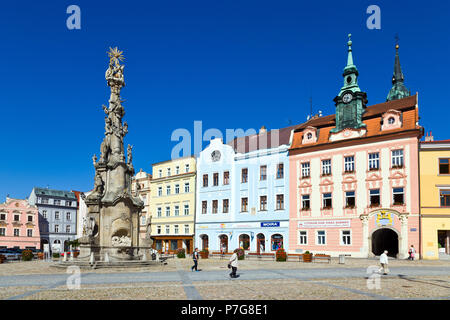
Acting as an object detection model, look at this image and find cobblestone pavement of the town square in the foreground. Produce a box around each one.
[0,259,450,300]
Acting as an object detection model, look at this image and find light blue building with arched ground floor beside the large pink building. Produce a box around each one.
[195,126,296,253]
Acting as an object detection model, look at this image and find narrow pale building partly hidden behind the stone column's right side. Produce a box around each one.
[131,169,152,239]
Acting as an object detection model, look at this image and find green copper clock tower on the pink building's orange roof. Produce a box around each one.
[331,34,367,133]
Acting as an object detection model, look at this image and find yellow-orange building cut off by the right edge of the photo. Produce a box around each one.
[420,136,450,259]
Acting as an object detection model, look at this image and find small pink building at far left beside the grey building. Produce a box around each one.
[0,198,41,249]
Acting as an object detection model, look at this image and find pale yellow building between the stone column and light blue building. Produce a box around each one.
[150,156,196,254]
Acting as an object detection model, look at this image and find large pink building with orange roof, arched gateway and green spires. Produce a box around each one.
[289,41,423,259]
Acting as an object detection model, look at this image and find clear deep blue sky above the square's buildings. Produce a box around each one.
[0,0,450,201]
